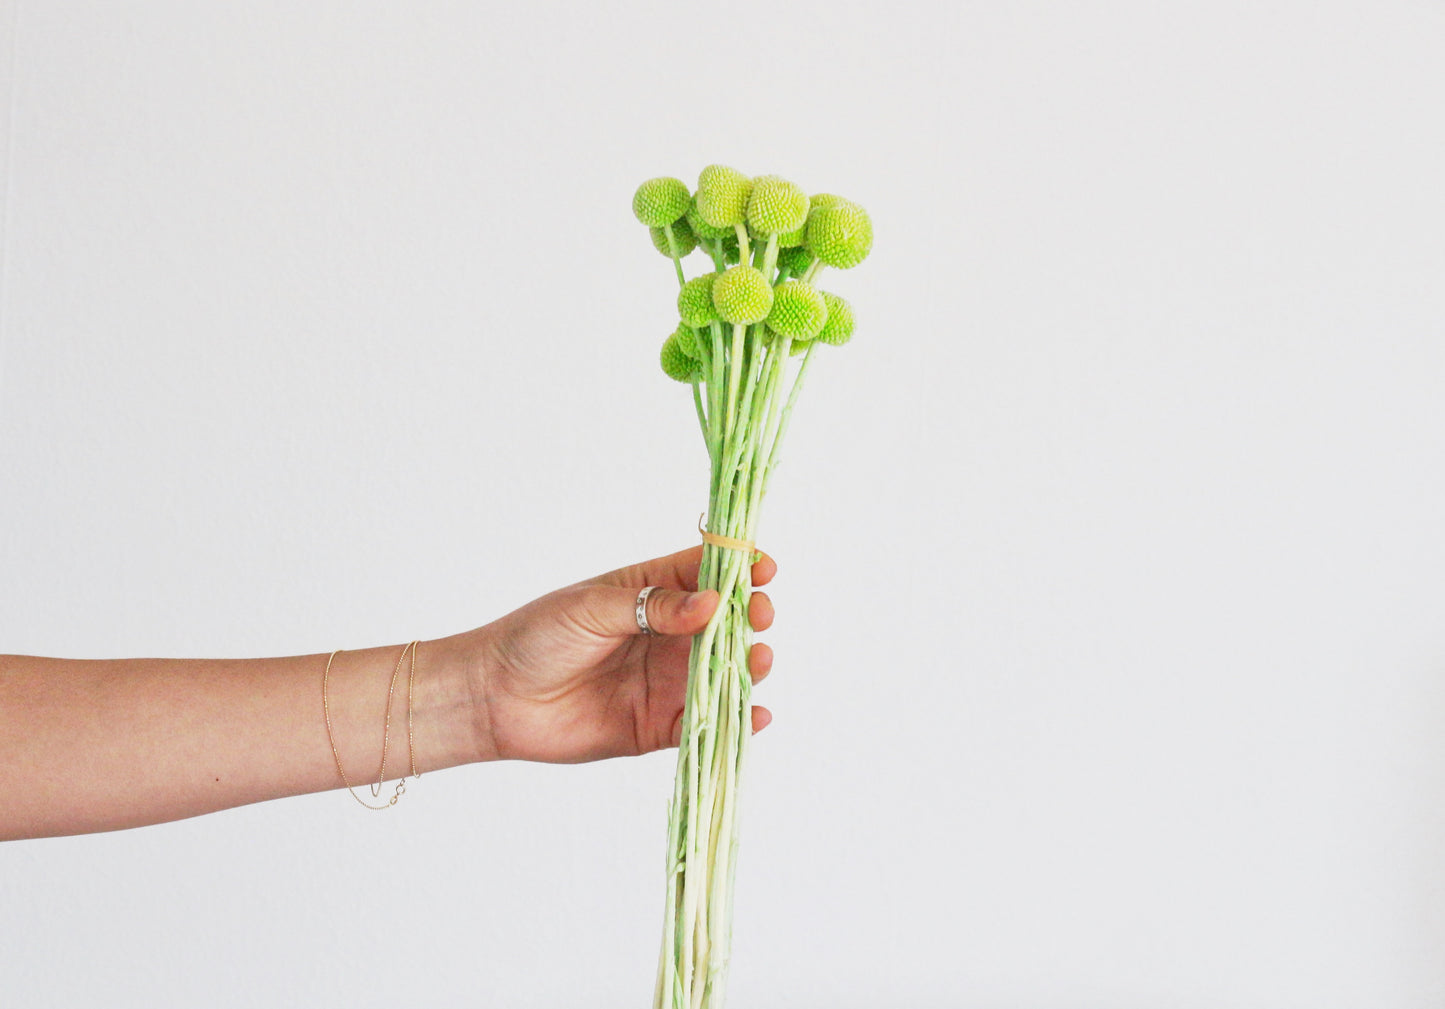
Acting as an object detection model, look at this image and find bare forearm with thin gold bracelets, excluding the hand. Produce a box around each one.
[0,636,486,840]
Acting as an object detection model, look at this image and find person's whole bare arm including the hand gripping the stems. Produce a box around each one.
[0,548,776,840]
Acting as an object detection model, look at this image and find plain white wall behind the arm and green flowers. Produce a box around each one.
[0,0,1445,1009]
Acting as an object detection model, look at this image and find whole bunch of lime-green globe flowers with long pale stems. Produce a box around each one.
[633,165,873,1009]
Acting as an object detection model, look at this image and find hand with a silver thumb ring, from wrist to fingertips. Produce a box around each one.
[468,546,777,763]
